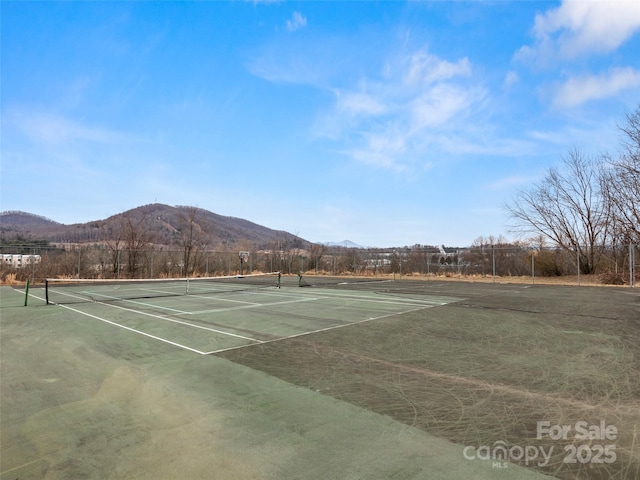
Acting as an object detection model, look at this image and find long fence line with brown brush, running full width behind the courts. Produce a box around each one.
[0,245,640,286]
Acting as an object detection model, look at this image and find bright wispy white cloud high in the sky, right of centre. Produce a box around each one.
[320,49,486,171]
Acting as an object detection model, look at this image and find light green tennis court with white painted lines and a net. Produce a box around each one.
[41,275,459,354]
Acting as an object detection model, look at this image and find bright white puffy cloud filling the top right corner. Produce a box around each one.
[516,0,640,63]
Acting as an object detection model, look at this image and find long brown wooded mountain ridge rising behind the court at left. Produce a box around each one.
[0,203,309,249]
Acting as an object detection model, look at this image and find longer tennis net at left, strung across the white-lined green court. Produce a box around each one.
[45,272,280,304]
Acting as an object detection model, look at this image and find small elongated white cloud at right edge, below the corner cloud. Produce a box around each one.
[553,68,640,107]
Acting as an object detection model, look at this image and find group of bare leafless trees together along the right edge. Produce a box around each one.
[507,105,640,274]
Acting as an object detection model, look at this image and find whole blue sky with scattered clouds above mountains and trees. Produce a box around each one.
[0,1,640,247]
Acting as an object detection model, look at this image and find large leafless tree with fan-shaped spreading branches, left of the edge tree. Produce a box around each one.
[507,150,610,274]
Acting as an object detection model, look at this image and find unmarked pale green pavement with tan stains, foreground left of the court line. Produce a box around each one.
[0,287,552,480]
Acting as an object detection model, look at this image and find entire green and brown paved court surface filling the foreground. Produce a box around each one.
[0,278,640,479]
